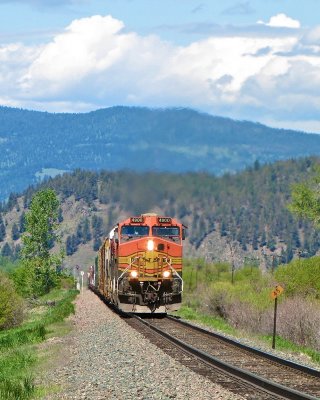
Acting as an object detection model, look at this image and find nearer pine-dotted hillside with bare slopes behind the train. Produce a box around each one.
[0,158,320,267]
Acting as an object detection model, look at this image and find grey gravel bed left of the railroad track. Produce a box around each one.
[42,290,243,400]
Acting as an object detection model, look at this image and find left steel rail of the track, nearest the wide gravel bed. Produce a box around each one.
[133,315,319,400]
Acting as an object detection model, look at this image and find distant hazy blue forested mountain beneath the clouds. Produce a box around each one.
[0,107,320,199]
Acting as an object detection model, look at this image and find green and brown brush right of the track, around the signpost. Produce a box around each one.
[178,257,320,363]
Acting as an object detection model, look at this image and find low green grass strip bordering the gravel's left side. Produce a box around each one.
[0,289,78,400]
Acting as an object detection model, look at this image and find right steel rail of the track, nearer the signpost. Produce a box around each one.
[166,315,320,379]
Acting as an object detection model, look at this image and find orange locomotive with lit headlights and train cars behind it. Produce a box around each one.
[89,214,186,313]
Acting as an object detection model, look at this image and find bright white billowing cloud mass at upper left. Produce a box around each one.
[22,15,123,90]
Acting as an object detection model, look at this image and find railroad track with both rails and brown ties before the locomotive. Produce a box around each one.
[126,316,320,400]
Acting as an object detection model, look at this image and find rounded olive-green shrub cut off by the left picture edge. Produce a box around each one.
[0,273,24,330]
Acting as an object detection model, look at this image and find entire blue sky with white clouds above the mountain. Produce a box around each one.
[0,0,320,133]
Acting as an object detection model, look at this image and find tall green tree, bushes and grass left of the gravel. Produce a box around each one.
[0,189,78,400]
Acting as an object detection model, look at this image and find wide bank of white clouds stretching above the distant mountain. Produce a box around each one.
[0,16,320,133]
